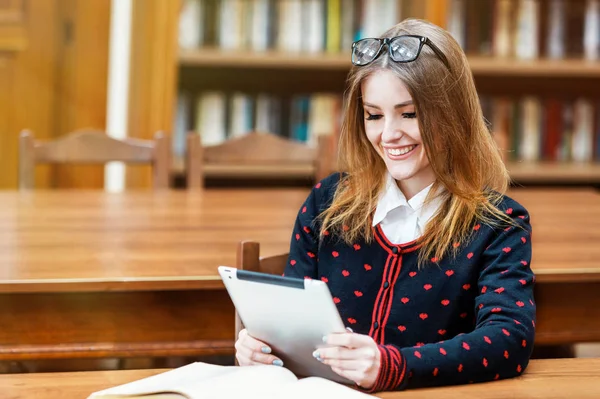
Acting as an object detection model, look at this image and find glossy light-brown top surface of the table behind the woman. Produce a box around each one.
[0,189,600,292]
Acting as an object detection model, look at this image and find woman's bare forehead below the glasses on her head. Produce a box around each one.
[361,69,411,106]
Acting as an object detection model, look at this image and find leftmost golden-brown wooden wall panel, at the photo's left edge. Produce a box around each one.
[0,0,58,188]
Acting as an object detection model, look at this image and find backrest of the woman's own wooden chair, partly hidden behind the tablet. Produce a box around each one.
[234,241,288,346]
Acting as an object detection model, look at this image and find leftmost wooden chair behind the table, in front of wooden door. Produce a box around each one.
[19,130,171,189]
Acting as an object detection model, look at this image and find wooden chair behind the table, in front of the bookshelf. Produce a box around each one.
[186,132,334,188]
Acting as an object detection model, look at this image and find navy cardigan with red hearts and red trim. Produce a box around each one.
[284,174,535,391]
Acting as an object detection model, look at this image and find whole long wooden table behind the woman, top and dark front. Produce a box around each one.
[0,189,600,360]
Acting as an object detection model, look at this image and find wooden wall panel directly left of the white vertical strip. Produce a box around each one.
[55,0,110,188]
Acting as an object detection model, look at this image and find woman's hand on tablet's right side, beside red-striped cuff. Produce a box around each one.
[313,332,381,389]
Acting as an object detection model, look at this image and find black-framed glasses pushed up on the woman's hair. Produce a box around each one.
[352,35,450,69]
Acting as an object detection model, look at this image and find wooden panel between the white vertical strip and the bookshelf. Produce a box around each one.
[126,0,181,188]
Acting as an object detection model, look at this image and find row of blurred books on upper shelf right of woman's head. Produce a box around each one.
[447,0,600,60]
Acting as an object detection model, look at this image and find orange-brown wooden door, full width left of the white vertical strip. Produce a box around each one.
[0,0,110,189]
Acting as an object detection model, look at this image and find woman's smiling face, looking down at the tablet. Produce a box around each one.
[361,69,435,199]
